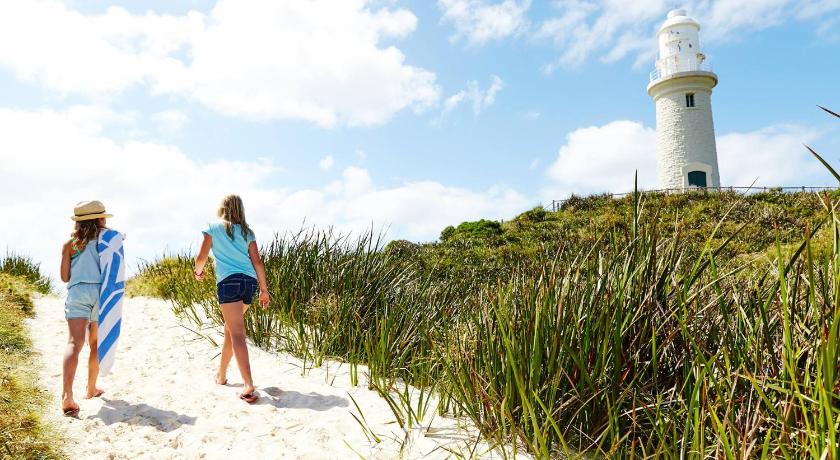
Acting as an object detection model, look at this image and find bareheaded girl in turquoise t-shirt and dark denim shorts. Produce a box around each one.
[195,195,269,404]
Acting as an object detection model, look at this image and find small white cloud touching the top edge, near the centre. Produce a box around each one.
[438,0,531,45]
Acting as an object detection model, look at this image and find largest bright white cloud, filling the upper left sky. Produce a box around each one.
[0,0,439,126]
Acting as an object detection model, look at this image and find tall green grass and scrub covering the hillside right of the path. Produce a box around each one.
[134,108,840,460]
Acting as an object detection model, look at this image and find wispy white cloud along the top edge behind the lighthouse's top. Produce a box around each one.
[534,0,840,71]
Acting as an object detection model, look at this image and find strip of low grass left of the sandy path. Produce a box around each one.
[0,255,62,459]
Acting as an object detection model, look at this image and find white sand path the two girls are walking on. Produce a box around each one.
[28,297,520,460]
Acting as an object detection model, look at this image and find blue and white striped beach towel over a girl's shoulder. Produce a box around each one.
[97,228,125,375]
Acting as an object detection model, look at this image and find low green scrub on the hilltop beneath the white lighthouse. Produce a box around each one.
[386,191,840,286]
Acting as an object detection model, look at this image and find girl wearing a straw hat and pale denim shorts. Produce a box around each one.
[61,201,112,417]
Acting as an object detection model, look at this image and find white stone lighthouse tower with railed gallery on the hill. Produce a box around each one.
[647,10,720,189]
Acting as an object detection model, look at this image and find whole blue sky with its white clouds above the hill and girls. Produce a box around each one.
[0,0,840,274]
